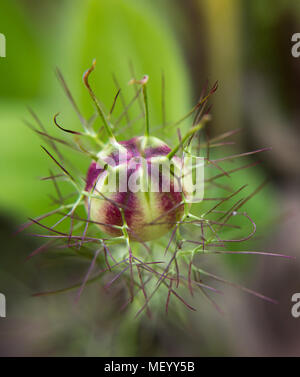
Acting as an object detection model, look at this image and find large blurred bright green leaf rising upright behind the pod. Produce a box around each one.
[60,0,190,139]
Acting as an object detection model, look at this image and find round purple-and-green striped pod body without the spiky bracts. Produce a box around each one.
[86,136,184,242]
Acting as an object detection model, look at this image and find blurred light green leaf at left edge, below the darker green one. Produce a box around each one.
[0,102,58,217]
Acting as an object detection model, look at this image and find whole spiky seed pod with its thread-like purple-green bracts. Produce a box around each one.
[22,62,292,315]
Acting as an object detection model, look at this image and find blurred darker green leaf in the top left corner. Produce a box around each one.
[0,0,45,99]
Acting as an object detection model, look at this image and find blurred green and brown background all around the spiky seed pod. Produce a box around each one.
[0,0,300,356]
